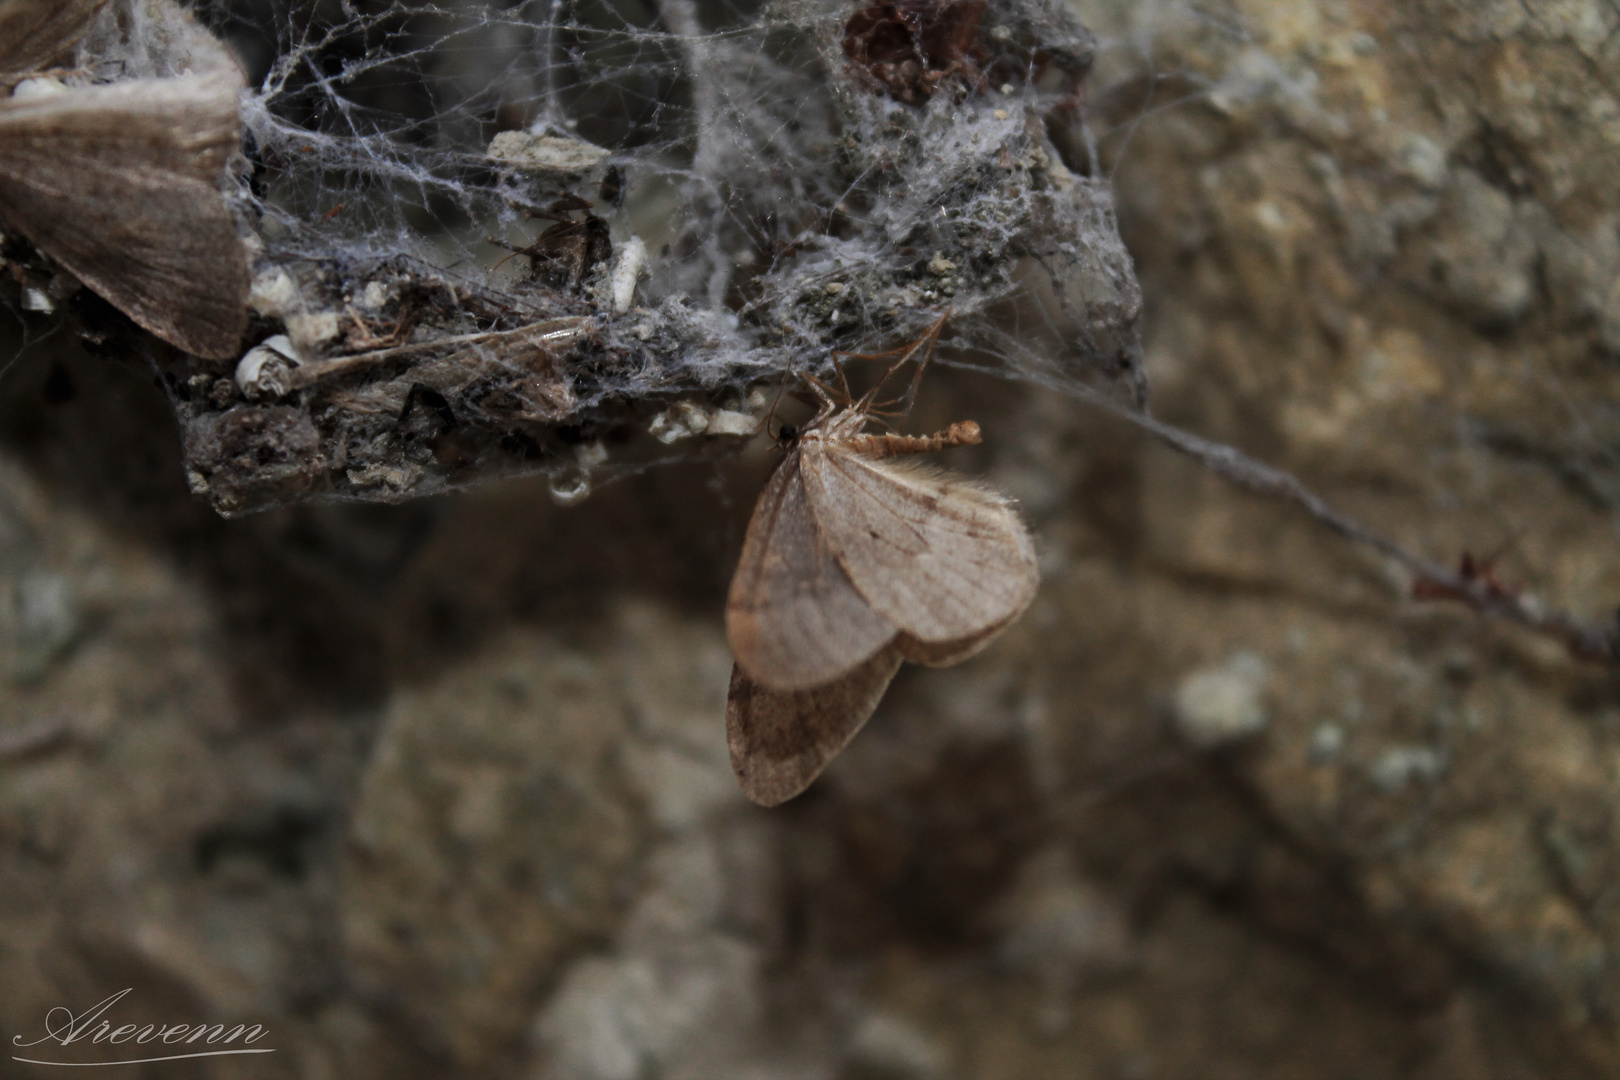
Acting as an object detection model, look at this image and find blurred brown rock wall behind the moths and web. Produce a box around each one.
[0,0,1620,1080]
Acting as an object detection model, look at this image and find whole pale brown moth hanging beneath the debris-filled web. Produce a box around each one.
[726,319,1040,806]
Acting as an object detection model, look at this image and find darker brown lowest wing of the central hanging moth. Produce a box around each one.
[726,646,901,806]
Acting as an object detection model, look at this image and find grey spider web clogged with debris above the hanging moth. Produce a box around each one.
[136,0,1145,513]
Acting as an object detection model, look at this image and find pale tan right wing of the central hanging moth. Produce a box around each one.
[804,444,1040,647]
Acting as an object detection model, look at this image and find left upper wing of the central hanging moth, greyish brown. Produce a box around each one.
[726,453,894,691]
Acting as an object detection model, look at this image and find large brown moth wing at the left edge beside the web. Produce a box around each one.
[0,71,248,358]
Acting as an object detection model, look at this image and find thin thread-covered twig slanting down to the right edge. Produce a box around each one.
[1066,387,1620,665]
